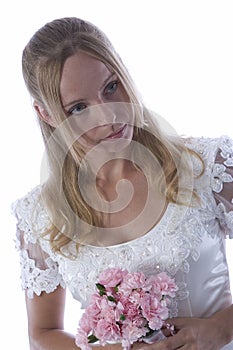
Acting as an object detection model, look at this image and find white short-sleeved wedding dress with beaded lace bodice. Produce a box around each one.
[12,136,233,350]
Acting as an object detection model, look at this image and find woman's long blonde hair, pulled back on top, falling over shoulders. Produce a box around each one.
[22,17,204,252]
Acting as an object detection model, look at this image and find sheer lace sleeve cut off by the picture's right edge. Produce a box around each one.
[211,137,233,238]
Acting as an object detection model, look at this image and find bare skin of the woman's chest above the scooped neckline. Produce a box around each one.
[90,174,166,246]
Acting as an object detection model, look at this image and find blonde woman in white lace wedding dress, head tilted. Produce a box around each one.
[13,18,233,350]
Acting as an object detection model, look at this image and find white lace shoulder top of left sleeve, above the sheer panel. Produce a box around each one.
[11,185,50,240]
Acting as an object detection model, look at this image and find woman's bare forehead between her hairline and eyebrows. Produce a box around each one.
[60,52,111,104]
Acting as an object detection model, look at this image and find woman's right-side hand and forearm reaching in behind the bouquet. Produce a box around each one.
[132,305,233,350]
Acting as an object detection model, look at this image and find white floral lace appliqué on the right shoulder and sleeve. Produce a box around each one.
[189,136,233,238]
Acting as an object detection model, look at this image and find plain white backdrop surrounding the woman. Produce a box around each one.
[0,0,233,350]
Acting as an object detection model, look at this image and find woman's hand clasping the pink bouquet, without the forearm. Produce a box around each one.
[133,317,225,350]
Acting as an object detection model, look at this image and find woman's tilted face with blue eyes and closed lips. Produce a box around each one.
[60,53,133,152]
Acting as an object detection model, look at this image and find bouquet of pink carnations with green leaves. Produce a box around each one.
[75,268,178,350]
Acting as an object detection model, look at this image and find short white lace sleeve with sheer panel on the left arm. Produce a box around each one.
[12,187,65,298]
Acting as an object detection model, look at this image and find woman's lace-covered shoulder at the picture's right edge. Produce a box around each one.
[187,135,233,238]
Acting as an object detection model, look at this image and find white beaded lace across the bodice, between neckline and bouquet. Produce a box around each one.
[60,205,203,308]
